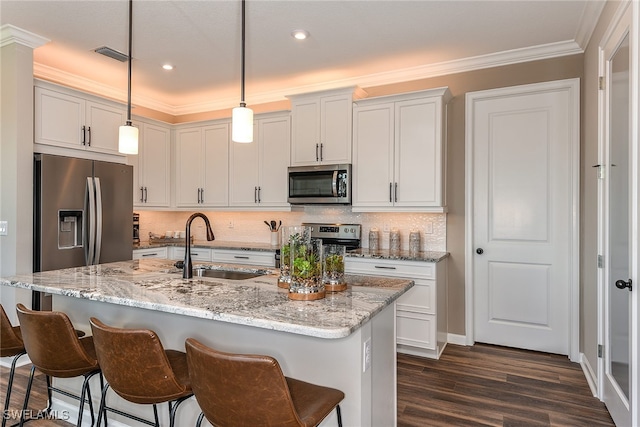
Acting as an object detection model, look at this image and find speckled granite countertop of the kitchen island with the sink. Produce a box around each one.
[0,259,413,339]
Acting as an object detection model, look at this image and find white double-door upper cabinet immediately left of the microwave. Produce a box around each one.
[229,112,291,210]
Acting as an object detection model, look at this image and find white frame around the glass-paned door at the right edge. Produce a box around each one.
[597,1,640,425]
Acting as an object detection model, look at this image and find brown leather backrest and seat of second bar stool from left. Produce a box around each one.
[16,304,100,378]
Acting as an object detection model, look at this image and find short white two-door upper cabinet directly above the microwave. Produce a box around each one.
[288,87,364,166]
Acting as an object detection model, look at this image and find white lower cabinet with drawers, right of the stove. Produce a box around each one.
[345,257,447,359]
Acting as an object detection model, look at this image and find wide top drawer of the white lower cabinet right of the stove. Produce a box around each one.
[345,257,436,279]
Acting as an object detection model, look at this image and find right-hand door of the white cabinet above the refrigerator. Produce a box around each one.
[85,101,126,154]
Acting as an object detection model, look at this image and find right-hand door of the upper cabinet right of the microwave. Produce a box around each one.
[394,98,442,207]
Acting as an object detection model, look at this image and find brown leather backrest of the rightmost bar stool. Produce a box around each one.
[185,338,305,427]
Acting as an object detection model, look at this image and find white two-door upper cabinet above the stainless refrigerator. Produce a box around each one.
[34,81,126,155]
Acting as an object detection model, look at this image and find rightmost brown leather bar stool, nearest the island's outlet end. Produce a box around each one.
[185,338,344,427]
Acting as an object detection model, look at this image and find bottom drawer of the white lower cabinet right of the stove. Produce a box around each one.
[396,310,437,350]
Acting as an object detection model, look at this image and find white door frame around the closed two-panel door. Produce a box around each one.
[464,78,580,362]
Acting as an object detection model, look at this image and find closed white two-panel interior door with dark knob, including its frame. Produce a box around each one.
[467,79,579,359]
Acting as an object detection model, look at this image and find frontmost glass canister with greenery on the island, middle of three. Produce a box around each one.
[289,239,326,301]
